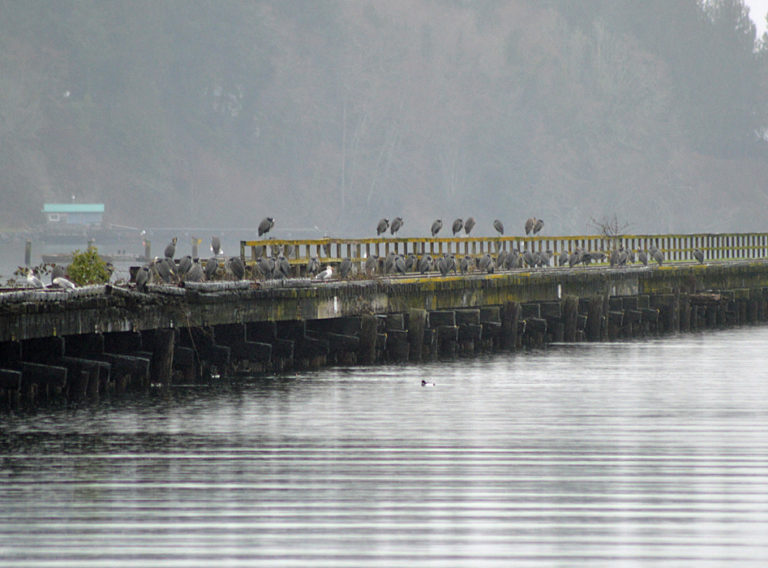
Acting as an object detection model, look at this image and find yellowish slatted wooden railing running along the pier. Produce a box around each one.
[240,233,768,264]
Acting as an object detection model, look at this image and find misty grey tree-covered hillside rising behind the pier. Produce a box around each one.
[0,0,768,238]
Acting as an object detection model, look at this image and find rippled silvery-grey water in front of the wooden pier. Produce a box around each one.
[0,328,768,567]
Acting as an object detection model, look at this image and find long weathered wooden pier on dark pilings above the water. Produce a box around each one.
[0,232,768,408]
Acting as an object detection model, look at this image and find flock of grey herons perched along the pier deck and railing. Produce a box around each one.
[120,217,704,291]
